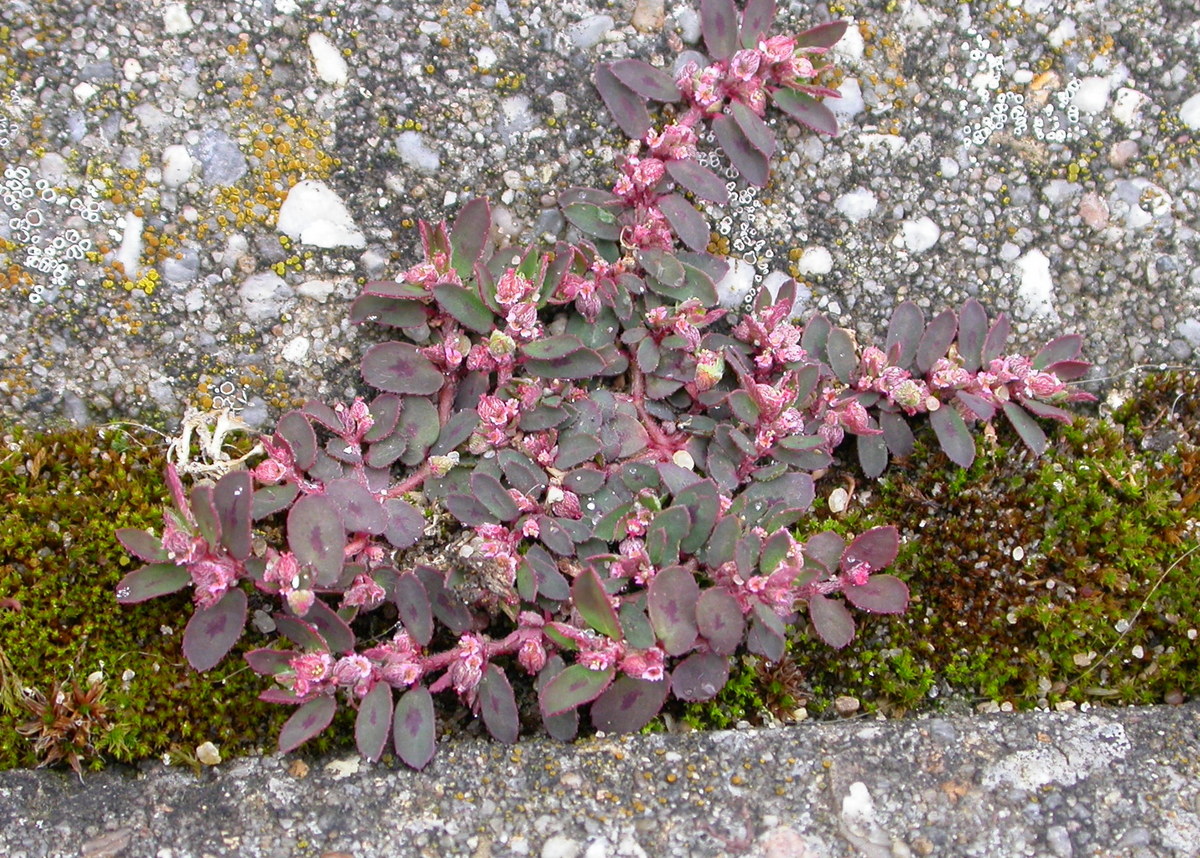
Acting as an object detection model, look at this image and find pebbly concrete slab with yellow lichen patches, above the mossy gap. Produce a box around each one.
[0,0,1200,425]
